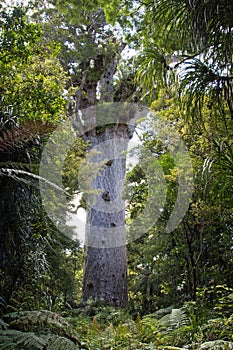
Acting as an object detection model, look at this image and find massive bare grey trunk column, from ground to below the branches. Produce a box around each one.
[83,124,132,306]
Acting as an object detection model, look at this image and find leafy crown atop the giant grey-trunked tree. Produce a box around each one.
[33,1,123,109]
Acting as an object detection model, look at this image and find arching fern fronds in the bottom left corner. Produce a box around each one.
[0,310,80,350]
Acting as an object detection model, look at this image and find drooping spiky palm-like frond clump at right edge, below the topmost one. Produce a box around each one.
[180,58,233,125]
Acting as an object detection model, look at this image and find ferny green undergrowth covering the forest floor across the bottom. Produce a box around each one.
[0,302,233,350]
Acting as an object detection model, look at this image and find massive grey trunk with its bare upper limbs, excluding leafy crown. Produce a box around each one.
[68,34,133,306]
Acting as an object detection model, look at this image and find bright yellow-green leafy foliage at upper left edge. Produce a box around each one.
[0,8,66,123]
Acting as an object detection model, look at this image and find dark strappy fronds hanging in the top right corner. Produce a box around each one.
[146,0,233,54]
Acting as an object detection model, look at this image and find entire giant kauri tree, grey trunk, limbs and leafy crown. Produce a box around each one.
[31,1,139,306]
